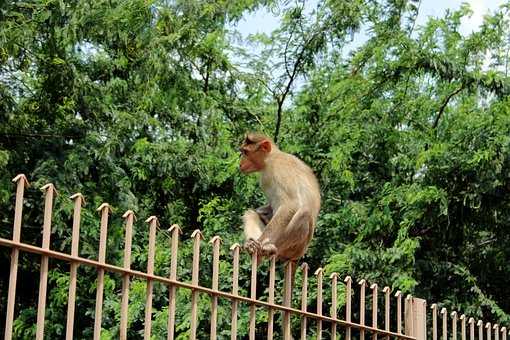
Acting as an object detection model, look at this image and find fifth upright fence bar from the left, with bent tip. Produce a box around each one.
[119,210,135,340]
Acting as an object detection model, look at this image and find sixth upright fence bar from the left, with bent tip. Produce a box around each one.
[143,216,158,340]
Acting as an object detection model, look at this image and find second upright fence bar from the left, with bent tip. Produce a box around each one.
[35,183,57,340]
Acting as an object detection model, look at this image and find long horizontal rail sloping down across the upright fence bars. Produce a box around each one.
[0,238,422,340]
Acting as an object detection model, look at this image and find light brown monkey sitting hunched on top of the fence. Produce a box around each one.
[239,133,321,261]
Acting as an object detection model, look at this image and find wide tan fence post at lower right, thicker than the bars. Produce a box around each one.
[404,295,427,340]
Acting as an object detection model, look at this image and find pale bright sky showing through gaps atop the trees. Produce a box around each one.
[237,0,506,37]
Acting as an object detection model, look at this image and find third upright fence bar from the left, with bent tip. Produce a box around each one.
[66,193,85,340]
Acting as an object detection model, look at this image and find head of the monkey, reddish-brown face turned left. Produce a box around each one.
[239,133,276,174]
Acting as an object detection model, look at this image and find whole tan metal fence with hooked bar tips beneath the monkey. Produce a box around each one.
[0,174,507,340]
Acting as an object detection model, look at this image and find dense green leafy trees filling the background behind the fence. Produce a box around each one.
[0,0,510,339]
